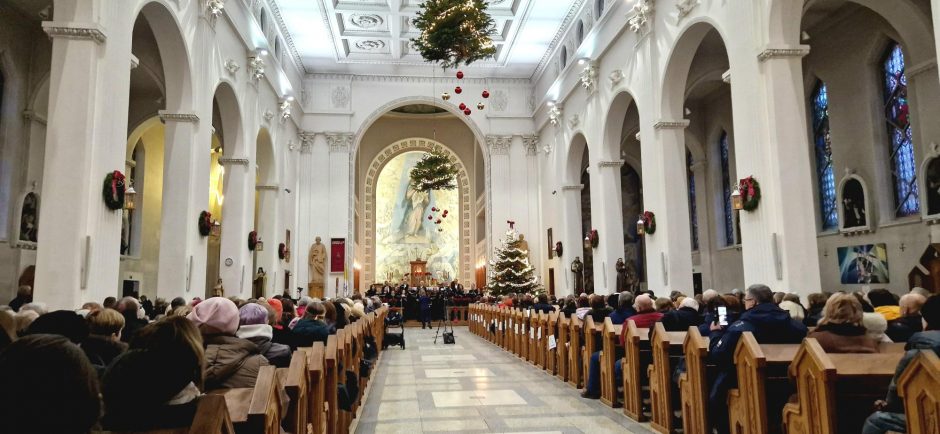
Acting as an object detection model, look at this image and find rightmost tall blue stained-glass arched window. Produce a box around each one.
[882,42,920,217]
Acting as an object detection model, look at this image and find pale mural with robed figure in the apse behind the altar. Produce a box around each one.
[375,152,460,281]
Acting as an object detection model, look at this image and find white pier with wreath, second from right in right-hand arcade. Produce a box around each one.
[640,116,692,295]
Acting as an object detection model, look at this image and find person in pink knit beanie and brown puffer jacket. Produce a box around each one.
[187,297,268,391]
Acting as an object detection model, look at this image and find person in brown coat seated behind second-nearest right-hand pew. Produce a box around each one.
[807,294,878,353]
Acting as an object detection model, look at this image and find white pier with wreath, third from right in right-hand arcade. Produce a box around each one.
[591,160,623,295]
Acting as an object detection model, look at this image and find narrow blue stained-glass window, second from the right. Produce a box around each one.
[812,81,839,229]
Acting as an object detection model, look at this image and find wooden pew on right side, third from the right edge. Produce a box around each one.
[728,332,799,434]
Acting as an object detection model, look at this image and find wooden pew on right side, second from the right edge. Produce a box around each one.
[783,338,904,434]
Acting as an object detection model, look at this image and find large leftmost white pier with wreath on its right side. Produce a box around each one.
[34,12,130,310]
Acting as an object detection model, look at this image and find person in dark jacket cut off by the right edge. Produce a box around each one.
[862,295,940,434]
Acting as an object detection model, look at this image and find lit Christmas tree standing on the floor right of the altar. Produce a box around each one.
[489,226,542,295]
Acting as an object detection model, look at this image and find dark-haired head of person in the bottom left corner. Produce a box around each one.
[0,334,101,434]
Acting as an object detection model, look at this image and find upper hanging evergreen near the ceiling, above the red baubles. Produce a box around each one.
[411,0,496,68]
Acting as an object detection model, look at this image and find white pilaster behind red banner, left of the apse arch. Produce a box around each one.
[323,133,355,297]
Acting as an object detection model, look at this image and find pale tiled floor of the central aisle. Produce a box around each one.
[356,327,651,434]
